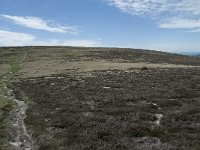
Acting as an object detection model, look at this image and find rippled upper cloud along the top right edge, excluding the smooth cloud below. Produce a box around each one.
[104,0,200,15]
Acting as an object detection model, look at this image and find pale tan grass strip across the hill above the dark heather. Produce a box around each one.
[20,60,197,78]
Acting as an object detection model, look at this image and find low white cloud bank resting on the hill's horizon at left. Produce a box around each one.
[0,30,101,47]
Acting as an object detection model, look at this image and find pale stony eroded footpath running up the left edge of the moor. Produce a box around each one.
[0,52,36,150]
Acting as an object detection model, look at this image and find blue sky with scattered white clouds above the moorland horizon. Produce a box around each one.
[0,0,200,52]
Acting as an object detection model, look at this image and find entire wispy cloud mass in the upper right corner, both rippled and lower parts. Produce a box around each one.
[104,0,200,32]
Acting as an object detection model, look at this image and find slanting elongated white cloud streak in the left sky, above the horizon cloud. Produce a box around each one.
[0,14,78,33]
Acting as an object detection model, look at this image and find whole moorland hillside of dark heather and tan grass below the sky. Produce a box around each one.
[0,47,200,150]
